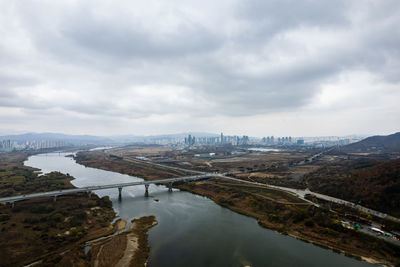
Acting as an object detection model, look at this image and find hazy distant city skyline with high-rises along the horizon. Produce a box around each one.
[0,133,364,153]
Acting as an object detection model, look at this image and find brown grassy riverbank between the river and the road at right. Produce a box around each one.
[77,153,400,265]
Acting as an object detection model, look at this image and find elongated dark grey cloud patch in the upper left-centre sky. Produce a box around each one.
[62,17,219,60]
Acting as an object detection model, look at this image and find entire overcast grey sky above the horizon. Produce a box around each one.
[0,0,400,136]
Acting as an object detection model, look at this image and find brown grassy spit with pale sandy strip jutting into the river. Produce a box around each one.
[90,216,158,267]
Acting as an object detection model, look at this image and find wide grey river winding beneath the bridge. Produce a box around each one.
[25,153,370,267]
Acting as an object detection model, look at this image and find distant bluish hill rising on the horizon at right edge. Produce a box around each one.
[341,132,400,152]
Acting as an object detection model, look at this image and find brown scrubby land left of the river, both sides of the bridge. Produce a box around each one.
[0,152,156,266]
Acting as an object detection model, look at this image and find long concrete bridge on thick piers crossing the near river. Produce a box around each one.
[0,173,216,206]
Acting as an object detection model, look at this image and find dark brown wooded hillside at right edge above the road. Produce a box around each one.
[306,158,400,217]
